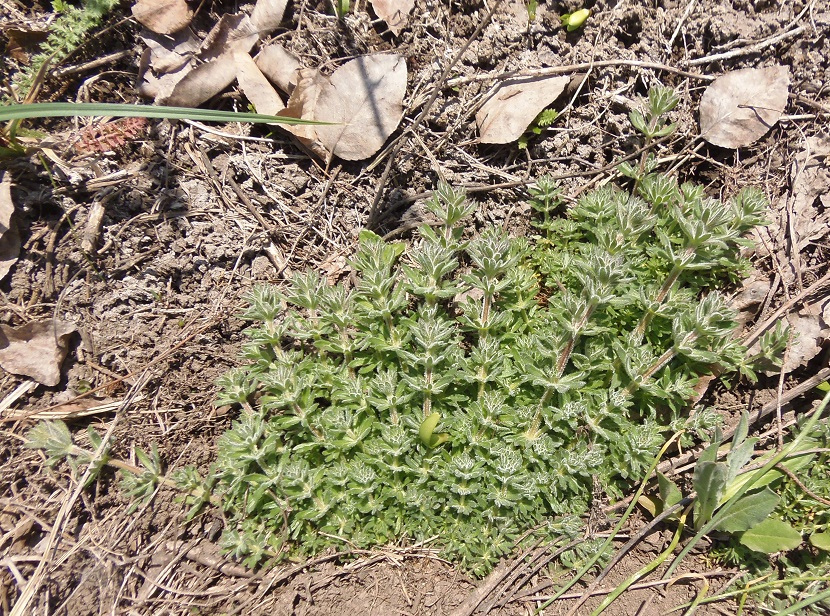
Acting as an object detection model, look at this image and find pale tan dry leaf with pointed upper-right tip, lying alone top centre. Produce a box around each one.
[476,76,571,143]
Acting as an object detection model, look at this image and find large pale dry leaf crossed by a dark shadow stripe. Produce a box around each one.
[313,54,407,160]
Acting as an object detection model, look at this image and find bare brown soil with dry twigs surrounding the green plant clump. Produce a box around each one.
[0,0,830,616]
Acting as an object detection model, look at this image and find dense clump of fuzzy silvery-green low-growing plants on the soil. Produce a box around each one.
[179,167,766,574]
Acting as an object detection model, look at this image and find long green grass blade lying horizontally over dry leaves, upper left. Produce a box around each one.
[0,103,329,124]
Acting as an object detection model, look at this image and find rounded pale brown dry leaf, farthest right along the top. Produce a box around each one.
[700,66,790,148]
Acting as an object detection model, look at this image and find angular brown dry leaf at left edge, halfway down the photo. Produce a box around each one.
[0,319,76,387]
